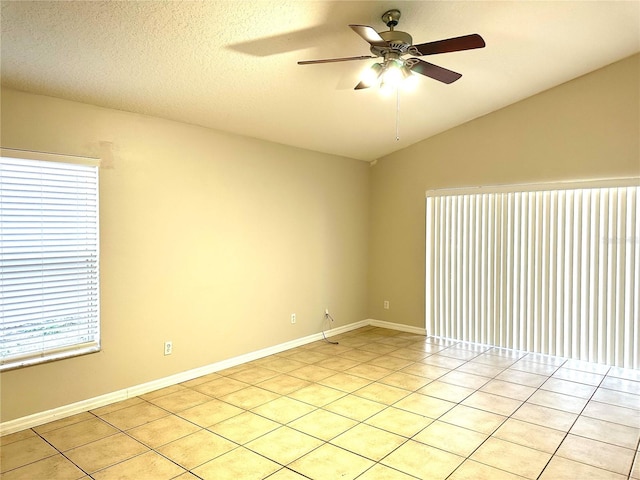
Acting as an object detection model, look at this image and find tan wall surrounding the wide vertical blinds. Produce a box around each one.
[368,55,640,327]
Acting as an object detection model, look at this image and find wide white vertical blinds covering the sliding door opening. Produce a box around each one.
[426,179,640,368]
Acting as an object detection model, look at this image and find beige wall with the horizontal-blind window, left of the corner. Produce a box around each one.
[0,90,369,421]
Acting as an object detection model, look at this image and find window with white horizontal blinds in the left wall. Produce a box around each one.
[0,149,100,370]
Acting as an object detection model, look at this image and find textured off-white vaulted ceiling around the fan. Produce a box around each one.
[1,0,640,161]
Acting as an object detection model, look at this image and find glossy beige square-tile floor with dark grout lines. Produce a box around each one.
[0,327,640,480]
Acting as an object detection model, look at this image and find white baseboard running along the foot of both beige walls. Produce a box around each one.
[0,319,425,436]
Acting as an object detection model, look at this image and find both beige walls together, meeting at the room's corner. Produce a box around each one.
[0,55,640,421]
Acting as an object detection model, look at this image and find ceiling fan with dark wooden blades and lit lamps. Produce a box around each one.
[298,9,485,90]
